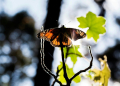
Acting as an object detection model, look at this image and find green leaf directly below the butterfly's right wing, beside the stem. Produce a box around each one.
[63,45,82,64]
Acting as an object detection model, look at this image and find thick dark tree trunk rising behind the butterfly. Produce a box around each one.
[34,0,62,86]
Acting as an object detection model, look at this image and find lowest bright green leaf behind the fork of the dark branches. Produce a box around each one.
[58,62,81,84]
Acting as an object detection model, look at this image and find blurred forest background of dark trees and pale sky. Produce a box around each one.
[0,0,120,86]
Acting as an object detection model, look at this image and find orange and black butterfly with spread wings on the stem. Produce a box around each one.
[37,26,86,47]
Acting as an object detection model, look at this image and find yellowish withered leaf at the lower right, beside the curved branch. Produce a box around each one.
[91,56,111,86]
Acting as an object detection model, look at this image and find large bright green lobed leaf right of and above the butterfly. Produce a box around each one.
[77,12,106,42]
